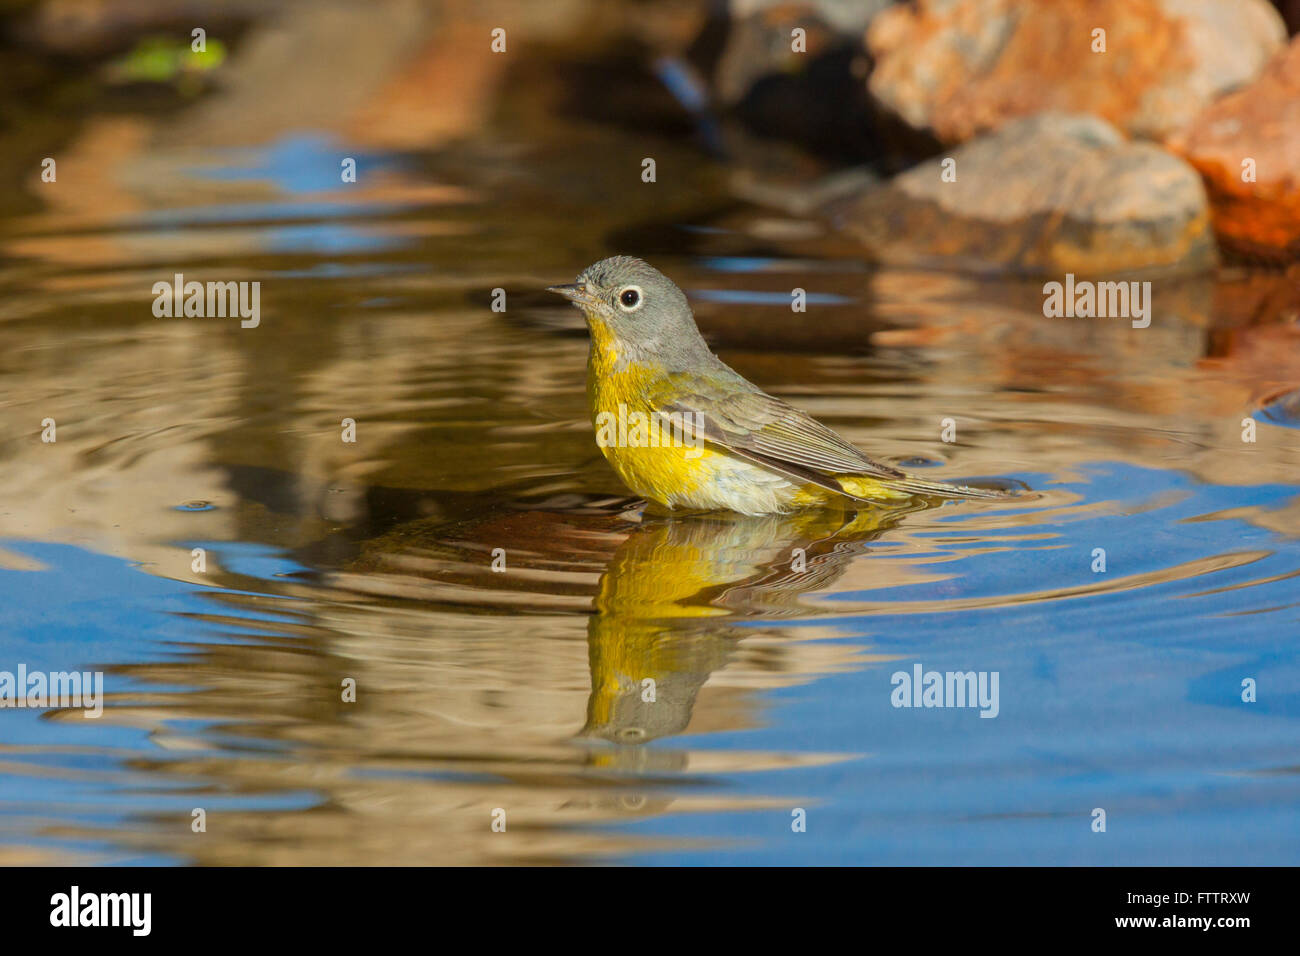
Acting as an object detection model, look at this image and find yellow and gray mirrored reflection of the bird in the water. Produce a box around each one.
[582,505,924,749]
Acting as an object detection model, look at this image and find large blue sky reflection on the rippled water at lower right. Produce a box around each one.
[611,464,1300,865]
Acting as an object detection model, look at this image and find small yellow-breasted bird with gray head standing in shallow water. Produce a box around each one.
[547,255,1006,515]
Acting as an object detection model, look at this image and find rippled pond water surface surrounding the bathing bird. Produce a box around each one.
[0,35,1300,864]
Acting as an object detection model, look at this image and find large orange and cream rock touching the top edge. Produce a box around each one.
[867,0,1287,143]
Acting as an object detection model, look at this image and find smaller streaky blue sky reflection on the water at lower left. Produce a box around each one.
[0,541,317,866]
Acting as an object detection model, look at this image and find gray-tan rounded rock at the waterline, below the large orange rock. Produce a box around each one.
[828,113,1216,277]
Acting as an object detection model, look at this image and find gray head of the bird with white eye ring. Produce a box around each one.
[547,256,712,368]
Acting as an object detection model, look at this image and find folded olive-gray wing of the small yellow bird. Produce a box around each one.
[657,390,906,493]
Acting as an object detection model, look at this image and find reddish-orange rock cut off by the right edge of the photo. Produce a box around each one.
[1170,36,1300,260]
